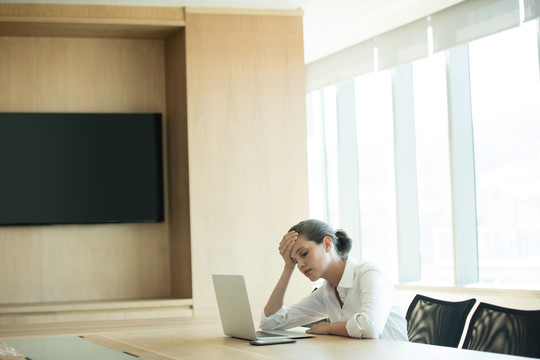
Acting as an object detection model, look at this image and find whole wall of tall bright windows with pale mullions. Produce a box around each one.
[308,20,540,289]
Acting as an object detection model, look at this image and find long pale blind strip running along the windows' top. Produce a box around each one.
[306,0,528,88]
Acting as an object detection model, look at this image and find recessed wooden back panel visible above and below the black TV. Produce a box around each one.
[0,37,170,303]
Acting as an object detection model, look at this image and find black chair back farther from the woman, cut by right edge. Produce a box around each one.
[463,303,540,358]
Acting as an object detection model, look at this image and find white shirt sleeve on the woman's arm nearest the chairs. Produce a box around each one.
[346,269,393,339]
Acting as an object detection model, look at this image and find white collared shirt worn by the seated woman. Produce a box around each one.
[260,256,408,341]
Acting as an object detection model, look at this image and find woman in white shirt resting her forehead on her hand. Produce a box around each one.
[260,220,407,341]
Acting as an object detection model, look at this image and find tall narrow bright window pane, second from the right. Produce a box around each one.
[413,52,454,284]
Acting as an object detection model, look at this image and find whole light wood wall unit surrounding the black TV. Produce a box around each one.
[0,4,309,322]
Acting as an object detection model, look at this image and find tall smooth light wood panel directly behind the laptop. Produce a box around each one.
[186,9,311,318]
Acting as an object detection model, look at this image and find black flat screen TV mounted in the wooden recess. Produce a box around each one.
[0,113,164,225]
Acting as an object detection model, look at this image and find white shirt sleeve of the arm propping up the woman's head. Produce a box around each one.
[259,289,328,330]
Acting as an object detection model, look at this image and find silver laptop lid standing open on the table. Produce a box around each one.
[212,274,257,340]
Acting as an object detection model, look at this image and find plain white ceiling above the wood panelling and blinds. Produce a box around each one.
[0,0,464,64]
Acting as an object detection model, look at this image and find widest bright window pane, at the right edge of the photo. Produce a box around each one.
[469,22,540,287]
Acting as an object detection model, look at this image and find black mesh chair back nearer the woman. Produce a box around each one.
[405,295,476,348]
